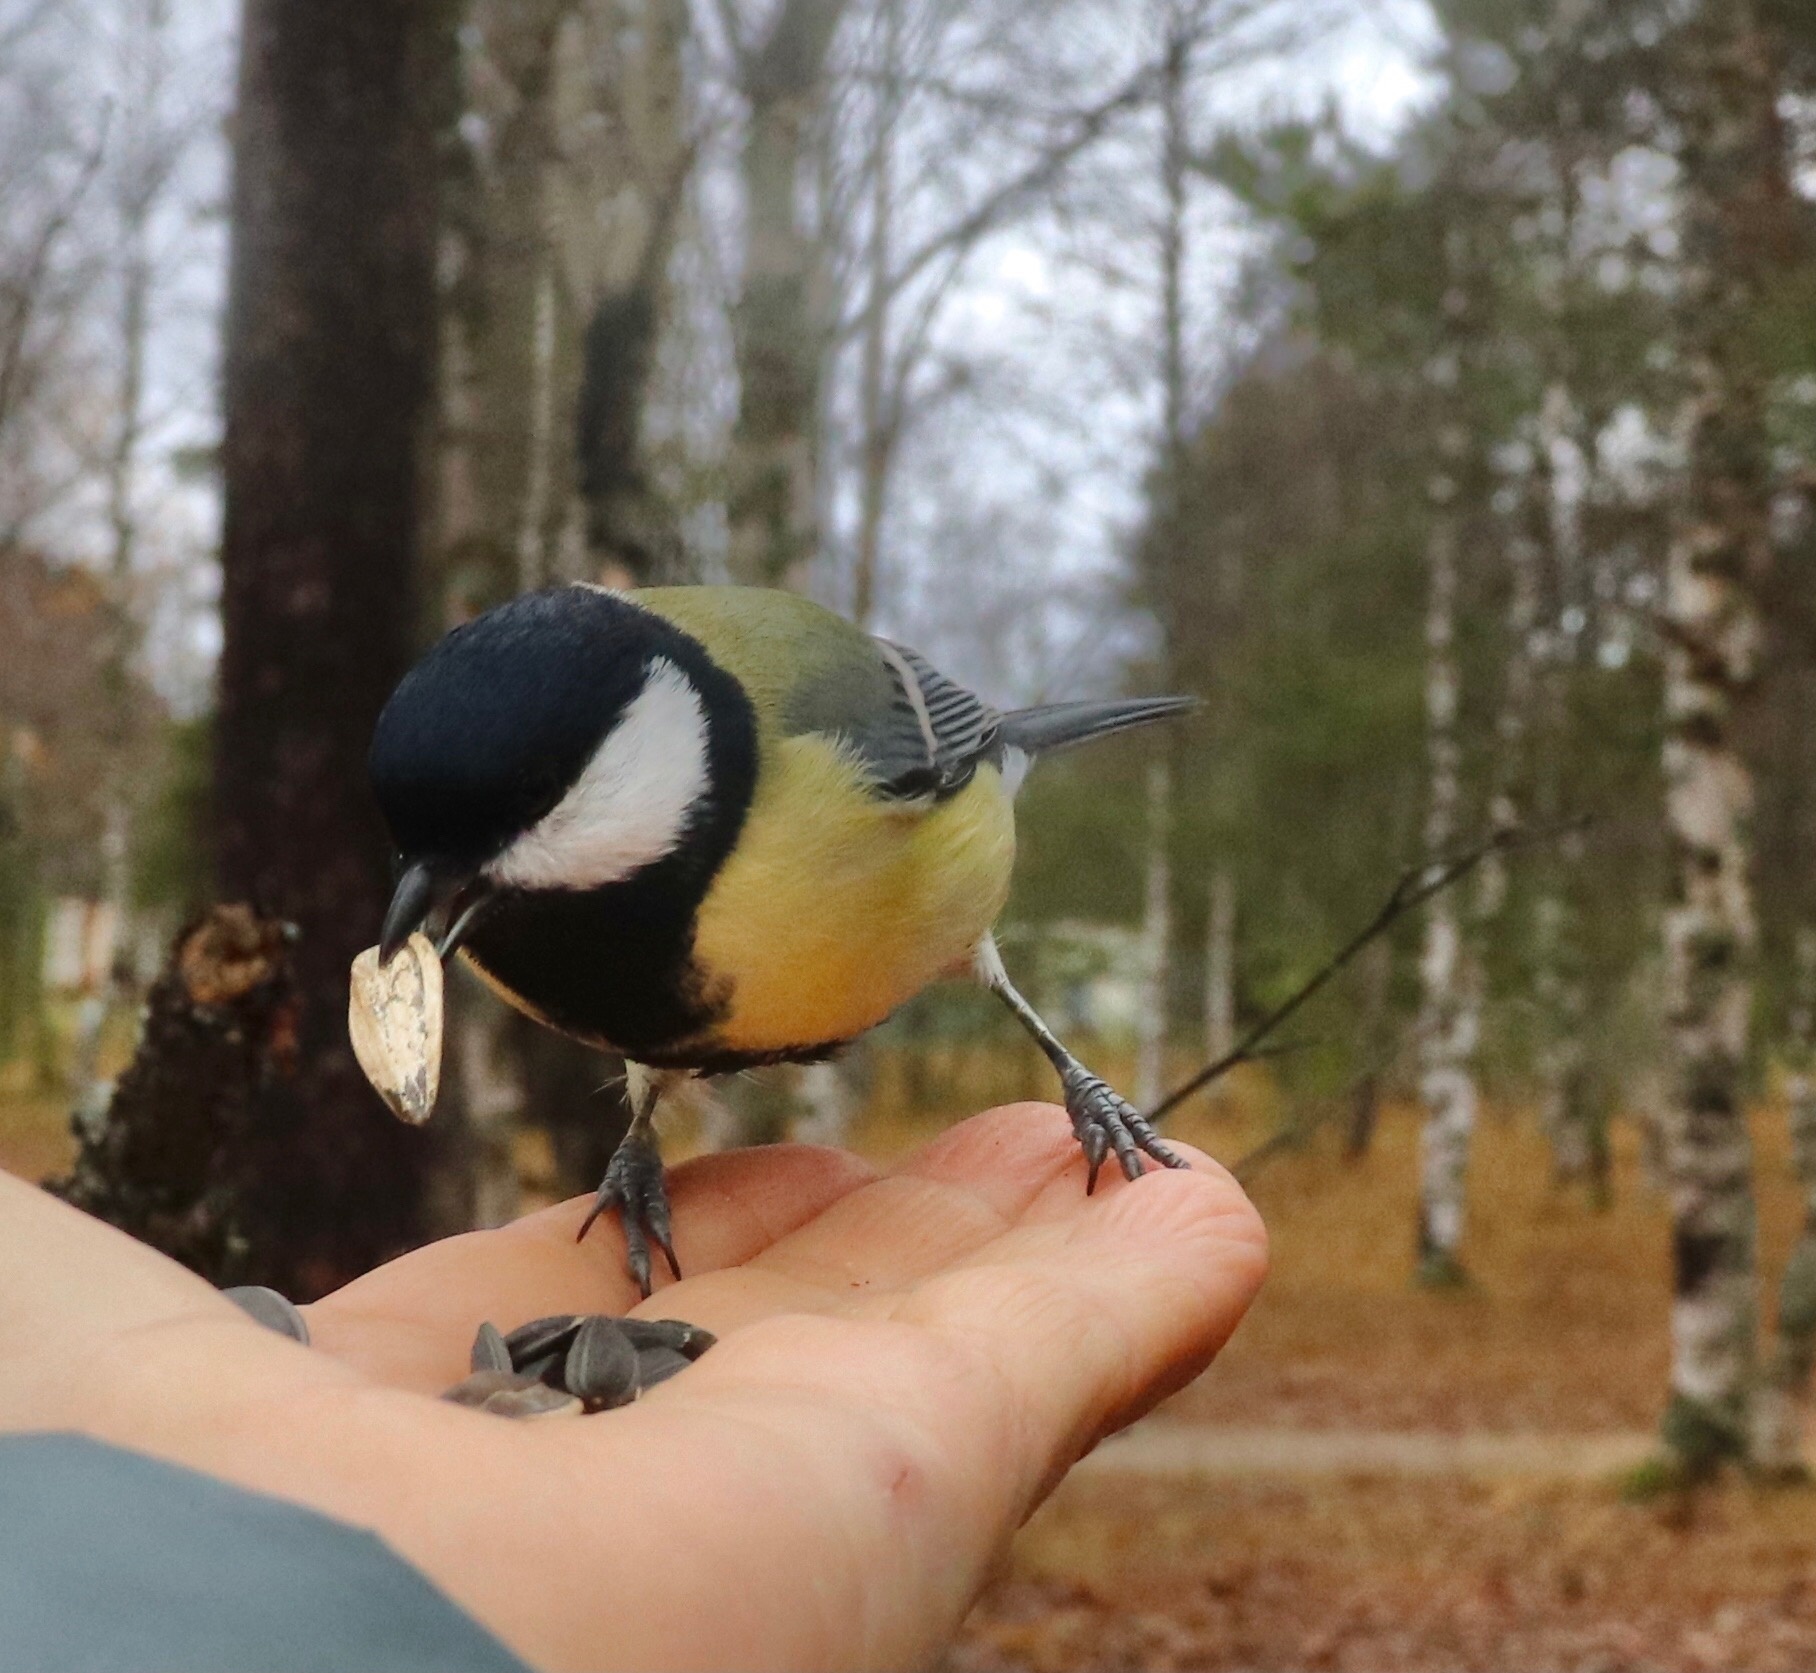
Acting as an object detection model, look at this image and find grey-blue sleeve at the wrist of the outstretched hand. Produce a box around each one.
[0,1435,528,1673]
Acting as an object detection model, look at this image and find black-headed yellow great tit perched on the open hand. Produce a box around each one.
[369,581,1195,1295]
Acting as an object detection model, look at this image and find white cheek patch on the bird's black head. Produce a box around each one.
[487,658,710,888]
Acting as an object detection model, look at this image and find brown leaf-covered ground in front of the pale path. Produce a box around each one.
[948,1479,1816,1673]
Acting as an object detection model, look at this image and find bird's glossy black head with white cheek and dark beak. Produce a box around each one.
[369,587,755,957]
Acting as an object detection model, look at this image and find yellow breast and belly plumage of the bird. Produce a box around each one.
[694,734,1015,1054]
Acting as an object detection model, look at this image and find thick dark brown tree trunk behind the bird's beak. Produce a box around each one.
[214,0,452,1299]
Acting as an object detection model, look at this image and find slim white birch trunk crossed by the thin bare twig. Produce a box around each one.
[1418,505,1478,1284]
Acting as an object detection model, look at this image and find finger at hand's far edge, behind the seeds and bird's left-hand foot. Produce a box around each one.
[305,1144,873,1391]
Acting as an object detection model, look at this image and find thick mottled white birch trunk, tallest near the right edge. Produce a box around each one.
[1663,0,1789,1475]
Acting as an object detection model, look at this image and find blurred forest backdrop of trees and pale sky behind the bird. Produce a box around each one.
[10,0,1816,1470]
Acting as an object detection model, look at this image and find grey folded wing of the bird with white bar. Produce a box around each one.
[792,639,1002,801]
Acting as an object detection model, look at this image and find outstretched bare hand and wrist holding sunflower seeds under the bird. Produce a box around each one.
[0,1104,1266,1669]
